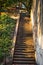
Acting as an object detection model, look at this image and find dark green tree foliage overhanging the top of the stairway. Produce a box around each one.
[0,0,32,10]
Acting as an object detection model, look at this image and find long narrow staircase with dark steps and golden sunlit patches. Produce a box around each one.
[12,14,36,65]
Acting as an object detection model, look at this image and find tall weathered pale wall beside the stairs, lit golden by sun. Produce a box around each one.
[31,0,43,65]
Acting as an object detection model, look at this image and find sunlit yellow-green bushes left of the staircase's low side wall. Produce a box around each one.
[0,14,16,62]
